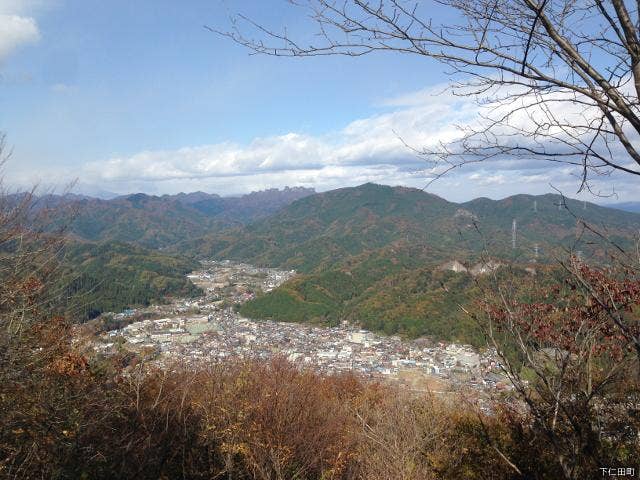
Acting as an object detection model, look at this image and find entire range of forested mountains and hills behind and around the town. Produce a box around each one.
[32,184,640,343]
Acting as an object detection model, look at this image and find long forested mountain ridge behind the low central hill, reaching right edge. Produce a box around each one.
[178,184,640,272]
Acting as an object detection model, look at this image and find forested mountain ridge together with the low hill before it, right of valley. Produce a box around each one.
[214,184,640,343]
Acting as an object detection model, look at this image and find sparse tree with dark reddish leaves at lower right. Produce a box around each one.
[473,257,640,479]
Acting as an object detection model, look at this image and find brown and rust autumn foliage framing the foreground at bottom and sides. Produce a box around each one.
[0,183,640,480]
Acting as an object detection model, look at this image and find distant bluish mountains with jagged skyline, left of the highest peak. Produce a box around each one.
[39,188,313,248]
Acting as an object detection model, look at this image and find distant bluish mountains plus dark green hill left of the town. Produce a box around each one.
[31,188,314,320]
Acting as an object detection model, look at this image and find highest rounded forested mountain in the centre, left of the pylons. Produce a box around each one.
[179,184,464,272]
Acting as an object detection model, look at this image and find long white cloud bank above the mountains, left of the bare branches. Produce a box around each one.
[79,89,473,193]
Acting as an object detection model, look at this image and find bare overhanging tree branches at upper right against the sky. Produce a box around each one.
[217,0,640,190]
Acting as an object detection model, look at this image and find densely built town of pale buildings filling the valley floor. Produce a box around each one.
[95,261,507,393]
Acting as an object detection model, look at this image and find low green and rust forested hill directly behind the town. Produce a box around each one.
[240,243,554,345]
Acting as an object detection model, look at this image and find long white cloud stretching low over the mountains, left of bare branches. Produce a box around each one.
[83,84,476,189]
